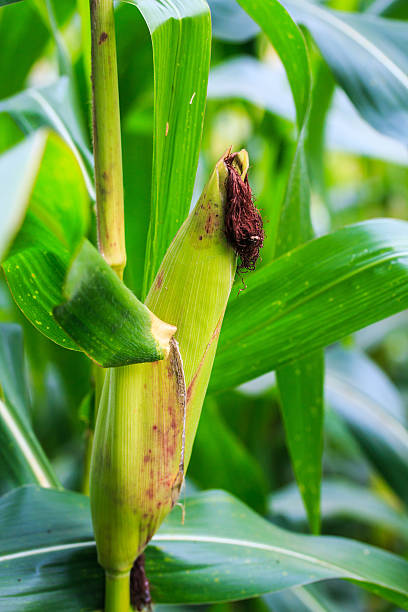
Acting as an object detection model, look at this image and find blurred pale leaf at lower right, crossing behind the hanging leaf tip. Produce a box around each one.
[269,478,408,540]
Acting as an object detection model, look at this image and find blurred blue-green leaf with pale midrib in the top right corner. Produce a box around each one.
[282,0,408,144]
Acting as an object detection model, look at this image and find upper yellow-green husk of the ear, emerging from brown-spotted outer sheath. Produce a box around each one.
[145,150,249,468]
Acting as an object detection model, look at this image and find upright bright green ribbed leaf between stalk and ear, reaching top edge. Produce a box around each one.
[121,0,211,297]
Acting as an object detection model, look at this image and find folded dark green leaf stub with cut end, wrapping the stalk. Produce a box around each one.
[53,240,171,368]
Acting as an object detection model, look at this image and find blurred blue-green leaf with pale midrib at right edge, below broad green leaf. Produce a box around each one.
[327,350,408,504]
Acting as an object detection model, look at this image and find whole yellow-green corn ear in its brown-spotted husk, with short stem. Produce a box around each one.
[90,151,248,612]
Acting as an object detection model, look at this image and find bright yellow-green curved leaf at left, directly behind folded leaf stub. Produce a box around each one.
[3,133,89,350]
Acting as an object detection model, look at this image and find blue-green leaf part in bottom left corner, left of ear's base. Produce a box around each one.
[0,486,104,612]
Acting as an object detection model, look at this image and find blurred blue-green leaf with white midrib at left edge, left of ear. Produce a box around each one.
[0,323,61,488]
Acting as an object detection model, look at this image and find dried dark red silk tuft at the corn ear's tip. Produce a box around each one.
[224,154,265,272]
